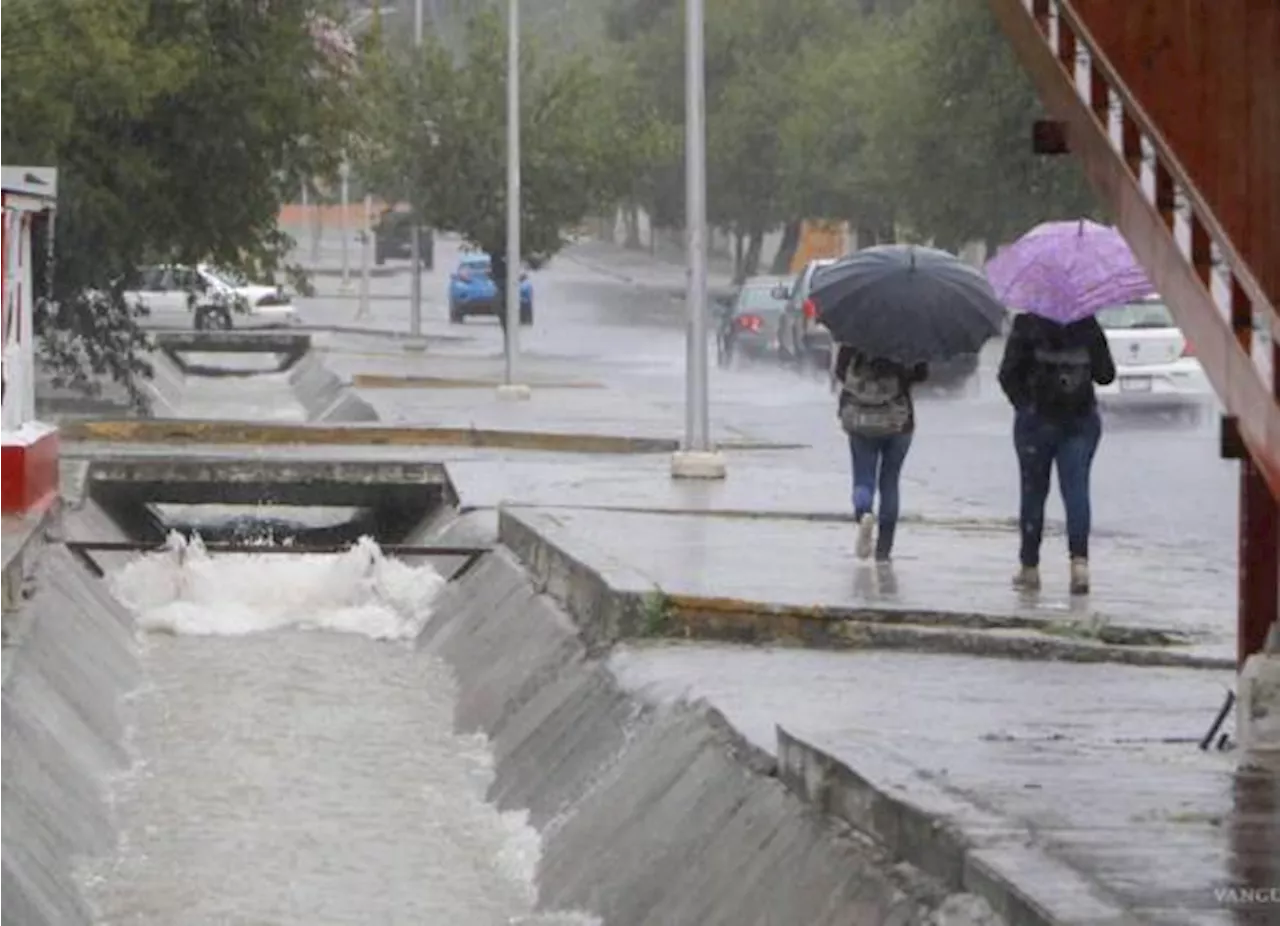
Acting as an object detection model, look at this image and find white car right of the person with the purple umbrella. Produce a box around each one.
[1097,298,1213,421]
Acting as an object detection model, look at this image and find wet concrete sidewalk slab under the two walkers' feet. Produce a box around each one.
[496,506,1234,666]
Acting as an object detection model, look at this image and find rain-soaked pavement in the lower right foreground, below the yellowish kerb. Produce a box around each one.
[612,644,1280,926]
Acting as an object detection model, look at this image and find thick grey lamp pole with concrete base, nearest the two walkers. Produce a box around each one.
[671,0,726,479]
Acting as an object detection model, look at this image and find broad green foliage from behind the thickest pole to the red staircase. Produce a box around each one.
[607,0,1094,253]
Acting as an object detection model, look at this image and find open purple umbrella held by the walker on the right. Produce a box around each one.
[986,219,1155,324]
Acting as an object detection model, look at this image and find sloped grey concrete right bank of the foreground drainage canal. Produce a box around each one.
[421,552,974,926]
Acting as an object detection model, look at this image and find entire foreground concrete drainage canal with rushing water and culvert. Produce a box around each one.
[0,460,993,926]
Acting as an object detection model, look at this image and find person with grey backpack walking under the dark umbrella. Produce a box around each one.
[835,345,929,562]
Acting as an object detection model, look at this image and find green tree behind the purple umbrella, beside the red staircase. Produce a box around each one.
[854,0,1097,248]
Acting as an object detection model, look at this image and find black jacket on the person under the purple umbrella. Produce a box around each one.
[1000,313,1116,418]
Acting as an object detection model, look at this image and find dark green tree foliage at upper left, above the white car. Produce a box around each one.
[0,0,355,394]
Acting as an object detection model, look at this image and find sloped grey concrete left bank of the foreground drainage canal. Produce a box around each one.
[0,547,140,926]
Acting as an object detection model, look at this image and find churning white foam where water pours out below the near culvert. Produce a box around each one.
[113,533,444,640]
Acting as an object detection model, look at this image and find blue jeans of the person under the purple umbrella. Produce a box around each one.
[1014,409,1102,566]
